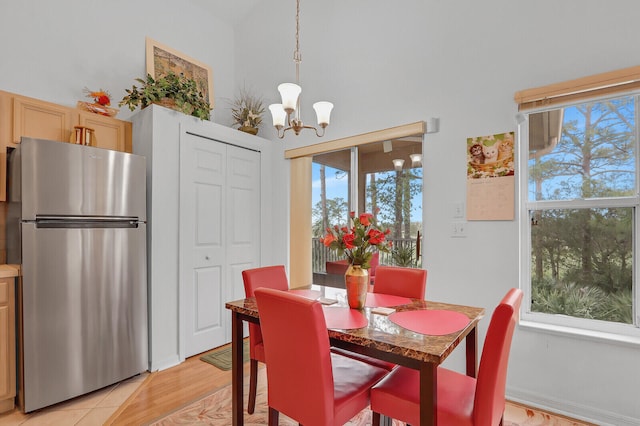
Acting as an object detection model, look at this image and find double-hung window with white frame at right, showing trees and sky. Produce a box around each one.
[519,92,640,336]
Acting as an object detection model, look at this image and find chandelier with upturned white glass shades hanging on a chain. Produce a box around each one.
[269,0,333,139]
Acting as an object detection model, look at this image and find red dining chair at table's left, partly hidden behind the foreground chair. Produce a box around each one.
[242,265,289,414]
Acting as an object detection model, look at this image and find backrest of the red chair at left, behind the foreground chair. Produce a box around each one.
[242,265,289,359]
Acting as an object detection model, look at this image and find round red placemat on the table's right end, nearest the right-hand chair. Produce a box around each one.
[389,310,469,336]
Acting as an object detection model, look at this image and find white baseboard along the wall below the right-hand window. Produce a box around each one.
[506,387,640,426]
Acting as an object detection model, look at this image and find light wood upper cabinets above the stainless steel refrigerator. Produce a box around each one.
[0,91,133,201]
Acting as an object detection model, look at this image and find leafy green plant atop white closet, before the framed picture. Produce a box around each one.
[118,72,211,120]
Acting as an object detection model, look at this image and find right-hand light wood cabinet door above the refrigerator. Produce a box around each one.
[78,111,131,152]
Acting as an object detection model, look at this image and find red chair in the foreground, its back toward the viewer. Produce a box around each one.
[255,288,388,426]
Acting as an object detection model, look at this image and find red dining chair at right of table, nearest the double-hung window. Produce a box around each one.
[371,288,522,426]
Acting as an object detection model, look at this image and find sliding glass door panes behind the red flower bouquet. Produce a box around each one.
[312,141,422,272]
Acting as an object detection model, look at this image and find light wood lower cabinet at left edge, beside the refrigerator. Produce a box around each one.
[0,278,16,413]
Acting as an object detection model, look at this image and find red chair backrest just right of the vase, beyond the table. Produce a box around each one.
[373,266,427,299]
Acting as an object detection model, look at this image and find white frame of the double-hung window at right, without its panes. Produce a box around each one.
[516,94,640,343]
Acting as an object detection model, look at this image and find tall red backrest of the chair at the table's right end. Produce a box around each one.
[473,288,522,425]
